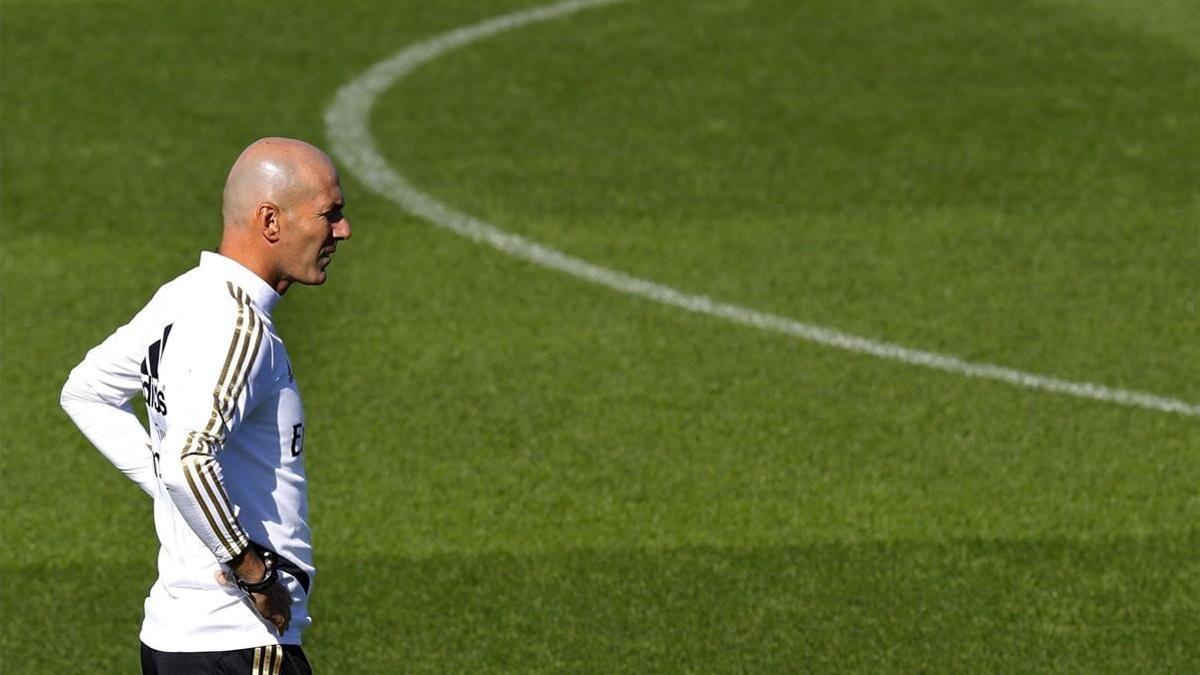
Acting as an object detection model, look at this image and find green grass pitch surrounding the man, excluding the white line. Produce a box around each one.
[0,0,1200,674]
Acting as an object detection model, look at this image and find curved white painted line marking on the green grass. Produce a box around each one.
[325,0,1200,417]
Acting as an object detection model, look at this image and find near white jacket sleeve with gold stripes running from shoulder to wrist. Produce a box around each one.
[158,286,264,562]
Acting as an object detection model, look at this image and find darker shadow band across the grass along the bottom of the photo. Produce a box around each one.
[0,534,1200,673]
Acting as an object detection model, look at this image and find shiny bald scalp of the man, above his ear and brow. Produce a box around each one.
[221,138,337,228]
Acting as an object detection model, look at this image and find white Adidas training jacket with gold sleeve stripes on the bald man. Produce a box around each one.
[61,252,316,652]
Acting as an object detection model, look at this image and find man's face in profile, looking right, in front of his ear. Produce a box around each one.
[278,167,350,285]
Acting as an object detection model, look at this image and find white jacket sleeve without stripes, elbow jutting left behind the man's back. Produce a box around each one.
[59,317,155,495]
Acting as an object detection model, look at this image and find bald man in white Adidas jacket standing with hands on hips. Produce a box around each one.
[61,138,350,674]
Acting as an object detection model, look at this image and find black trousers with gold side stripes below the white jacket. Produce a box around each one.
[142,644,312,675]
